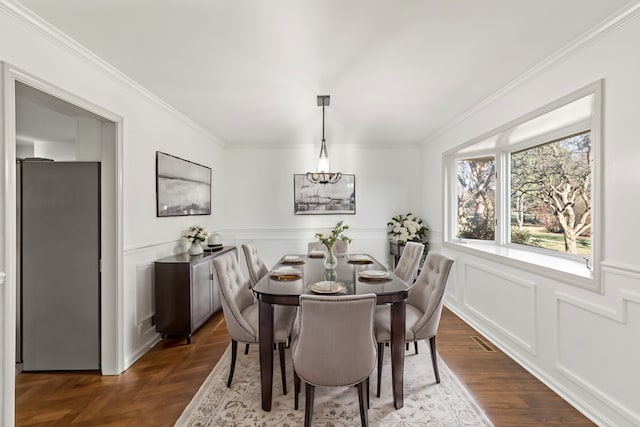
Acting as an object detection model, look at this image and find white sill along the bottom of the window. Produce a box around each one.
[444,241,598,291]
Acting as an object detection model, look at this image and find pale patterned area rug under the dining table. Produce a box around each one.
[175,342,492,427]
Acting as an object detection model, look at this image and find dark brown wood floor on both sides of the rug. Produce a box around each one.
[16,308,594,427]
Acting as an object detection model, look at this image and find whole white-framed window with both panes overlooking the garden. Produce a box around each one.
[445,82,601,289]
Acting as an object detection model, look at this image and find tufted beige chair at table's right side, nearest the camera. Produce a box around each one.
[375,252,453,397]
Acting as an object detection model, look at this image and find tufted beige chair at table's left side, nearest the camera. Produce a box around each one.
[213,252,296,394]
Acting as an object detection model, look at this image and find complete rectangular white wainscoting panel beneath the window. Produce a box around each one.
[463,263,536,355]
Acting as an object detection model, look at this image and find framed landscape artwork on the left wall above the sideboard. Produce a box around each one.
[156,151,211,217]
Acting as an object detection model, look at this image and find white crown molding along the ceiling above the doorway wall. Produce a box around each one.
[0,0,228,148]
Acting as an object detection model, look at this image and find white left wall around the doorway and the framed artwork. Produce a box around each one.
[0,1,224,425]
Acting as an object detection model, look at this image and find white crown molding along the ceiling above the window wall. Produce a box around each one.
[420,0,640,147]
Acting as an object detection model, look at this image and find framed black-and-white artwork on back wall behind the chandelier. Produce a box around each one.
[293,174,356,215]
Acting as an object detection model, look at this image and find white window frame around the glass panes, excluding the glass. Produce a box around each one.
[443,80,603,292]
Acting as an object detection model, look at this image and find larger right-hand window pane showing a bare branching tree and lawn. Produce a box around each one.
[510,132,592,256]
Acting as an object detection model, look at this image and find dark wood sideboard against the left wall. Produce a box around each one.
[154,246,236,344]
